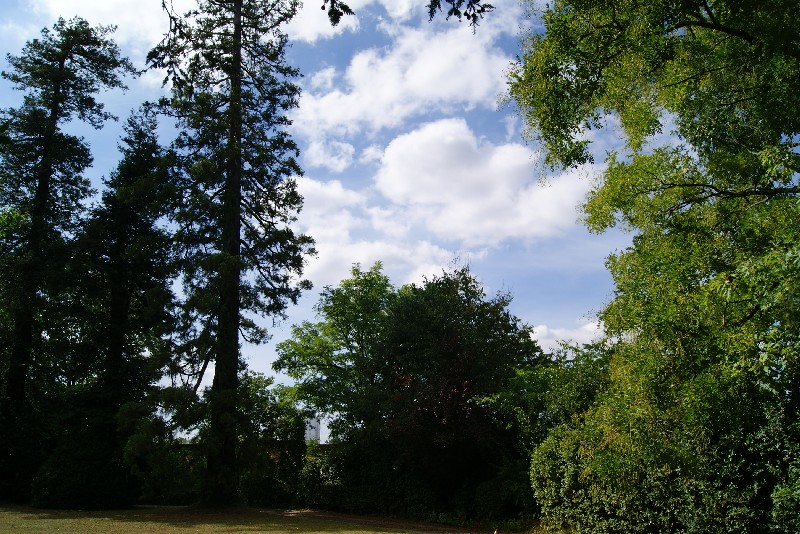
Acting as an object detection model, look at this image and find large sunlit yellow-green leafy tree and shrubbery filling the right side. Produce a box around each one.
[510,0,800,531]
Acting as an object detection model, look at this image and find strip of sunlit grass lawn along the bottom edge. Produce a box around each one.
[0,504,491,534]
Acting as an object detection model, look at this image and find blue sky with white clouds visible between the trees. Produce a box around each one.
[0,0,630,381]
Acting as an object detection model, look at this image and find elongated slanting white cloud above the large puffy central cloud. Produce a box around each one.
[293,20,510,147]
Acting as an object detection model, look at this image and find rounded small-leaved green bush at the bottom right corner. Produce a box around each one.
[531,372,800,533]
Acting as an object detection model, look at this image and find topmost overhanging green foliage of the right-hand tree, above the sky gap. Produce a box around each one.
[510,0,799,172]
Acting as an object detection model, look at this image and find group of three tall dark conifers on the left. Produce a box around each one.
[0,9,313,507]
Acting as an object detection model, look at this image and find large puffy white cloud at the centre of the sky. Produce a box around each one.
[375,119,589,247]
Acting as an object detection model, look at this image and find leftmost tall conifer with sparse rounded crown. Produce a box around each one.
[0,18,136,502]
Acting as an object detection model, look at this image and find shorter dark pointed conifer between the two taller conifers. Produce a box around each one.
[33,106,175,509]
